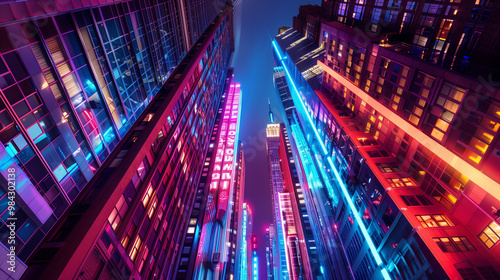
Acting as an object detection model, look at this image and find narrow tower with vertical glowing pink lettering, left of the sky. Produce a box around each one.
[186,69,245,279]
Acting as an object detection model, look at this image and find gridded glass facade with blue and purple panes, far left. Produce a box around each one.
[0,1,227,279]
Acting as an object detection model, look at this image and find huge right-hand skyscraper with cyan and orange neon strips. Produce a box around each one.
[273,1,500,279]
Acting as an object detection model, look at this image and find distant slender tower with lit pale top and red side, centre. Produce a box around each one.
[267,118,321,279]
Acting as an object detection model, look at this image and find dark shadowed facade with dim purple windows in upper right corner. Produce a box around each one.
[320,0,500,74]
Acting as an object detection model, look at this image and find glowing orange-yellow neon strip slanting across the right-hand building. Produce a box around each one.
[318,60,500,200]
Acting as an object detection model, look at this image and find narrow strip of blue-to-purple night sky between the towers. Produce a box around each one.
[234,0,321,279]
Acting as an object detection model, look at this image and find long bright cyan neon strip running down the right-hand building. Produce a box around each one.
[272,40,391,279]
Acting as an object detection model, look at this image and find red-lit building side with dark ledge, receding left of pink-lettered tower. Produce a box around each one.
[19,4,232,279]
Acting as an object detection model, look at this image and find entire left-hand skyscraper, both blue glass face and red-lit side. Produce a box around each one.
[0,1,236,279]
